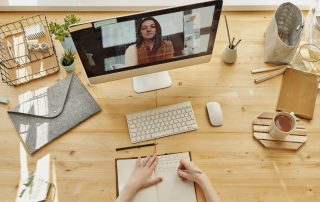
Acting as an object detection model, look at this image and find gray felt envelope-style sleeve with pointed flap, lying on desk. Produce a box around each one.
[8,75,101,154]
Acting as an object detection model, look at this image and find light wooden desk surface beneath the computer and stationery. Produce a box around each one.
[0,12,320,202]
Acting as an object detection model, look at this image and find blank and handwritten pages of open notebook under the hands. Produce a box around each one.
[116,152,197,202]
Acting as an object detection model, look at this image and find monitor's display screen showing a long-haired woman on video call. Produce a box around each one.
[71,2,217,77]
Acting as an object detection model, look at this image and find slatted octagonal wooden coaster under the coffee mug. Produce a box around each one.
[252,112,307,150]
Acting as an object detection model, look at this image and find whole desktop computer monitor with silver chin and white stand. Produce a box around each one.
[69,1,222,92]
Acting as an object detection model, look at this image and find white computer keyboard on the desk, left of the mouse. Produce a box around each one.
[126,102,198,143]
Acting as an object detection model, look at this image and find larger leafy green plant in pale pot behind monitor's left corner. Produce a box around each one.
[49,14,80,51]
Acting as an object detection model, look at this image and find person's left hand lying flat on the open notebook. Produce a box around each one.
[126,154,162,191]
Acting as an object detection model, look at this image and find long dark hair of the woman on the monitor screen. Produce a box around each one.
[136,17,162,52]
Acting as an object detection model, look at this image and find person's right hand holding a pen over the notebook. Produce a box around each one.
[178,159,206,184]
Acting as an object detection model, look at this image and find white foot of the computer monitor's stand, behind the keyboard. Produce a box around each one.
[133,71,172,93]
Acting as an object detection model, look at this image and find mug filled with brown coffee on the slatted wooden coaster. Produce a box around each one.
[269,112,296,139]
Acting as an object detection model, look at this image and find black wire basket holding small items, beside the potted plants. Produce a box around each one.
[0,15,60,86]
